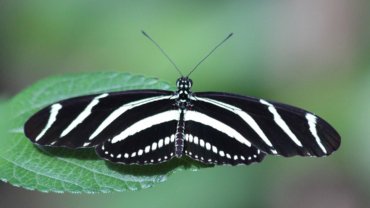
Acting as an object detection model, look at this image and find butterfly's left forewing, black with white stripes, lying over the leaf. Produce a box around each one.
[25,90,173,148]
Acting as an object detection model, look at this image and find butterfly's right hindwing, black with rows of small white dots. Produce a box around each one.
[184,117,265,165]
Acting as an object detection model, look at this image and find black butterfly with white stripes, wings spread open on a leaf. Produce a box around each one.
[24,32,340,165]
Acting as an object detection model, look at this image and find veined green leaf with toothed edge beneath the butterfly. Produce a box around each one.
[0,73,201,193]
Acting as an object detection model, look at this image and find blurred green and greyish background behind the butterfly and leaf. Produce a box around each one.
[0,0,370,208]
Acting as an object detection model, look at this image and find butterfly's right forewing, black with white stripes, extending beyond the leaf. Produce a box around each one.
[191,92,340,156]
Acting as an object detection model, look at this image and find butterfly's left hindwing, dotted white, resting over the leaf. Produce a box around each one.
[96,117,177,165]
